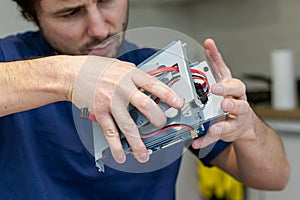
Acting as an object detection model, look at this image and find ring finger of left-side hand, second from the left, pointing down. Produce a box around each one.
[111,101,149,163]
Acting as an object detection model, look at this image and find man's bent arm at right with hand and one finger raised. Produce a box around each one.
[193,39,290,190]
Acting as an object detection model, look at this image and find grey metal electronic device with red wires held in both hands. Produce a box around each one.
[82,41,226,171]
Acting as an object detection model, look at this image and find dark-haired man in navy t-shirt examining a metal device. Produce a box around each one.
[0,0,290,199]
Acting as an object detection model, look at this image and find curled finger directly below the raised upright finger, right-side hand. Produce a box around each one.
[212,79,246,99]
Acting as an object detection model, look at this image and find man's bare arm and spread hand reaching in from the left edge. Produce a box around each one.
[0,56,184,163]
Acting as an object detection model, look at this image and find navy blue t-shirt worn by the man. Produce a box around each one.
[0,32,227,200]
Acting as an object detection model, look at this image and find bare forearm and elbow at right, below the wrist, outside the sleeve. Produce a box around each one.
[213,111,290,190]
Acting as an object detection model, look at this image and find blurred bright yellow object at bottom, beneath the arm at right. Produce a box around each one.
[198,161,244,200]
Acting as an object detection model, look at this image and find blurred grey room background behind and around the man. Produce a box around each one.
[0,0,300,200]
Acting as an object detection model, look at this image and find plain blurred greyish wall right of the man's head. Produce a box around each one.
[130,0,300,77]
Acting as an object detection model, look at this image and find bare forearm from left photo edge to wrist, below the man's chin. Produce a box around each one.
[0,56,76,116]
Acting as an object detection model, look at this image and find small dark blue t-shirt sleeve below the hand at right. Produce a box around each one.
[189,140,231,167]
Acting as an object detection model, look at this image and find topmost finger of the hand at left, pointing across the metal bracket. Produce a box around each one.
[133,69,184,109]
